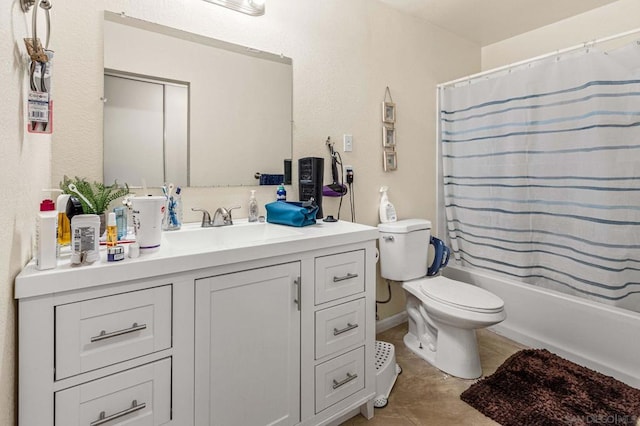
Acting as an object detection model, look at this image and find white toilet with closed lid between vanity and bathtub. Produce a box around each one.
[378,219,506,379]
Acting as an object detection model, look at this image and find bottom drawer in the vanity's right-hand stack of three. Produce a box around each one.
[316,346,364,413]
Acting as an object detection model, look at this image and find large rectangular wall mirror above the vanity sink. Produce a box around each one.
[104,12,293,187]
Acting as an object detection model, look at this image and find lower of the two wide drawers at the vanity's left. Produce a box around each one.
[55,358,171,426]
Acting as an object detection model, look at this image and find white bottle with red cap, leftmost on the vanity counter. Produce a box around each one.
[35,199,58,270]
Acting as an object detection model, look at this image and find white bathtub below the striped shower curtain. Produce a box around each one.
[443,262,640,388]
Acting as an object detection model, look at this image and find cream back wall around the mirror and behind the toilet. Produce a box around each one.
[53,0,480,317]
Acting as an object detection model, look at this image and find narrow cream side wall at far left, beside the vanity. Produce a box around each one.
[0,1,51,425]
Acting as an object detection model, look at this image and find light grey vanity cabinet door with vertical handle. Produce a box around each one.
[195,262,300,426]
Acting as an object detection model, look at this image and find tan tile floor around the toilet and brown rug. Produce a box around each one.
[342,323,525,426]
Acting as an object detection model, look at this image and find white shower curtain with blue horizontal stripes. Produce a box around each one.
[439,42,640,311]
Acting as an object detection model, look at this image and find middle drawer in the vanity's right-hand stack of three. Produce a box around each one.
[316,298,365,359]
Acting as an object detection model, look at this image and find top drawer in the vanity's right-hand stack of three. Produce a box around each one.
[316,250,364,305]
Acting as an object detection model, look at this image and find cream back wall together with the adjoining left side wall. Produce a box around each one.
[0,0,480,425]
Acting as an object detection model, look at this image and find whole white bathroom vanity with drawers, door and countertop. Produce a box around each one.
[15,222,378,426]
